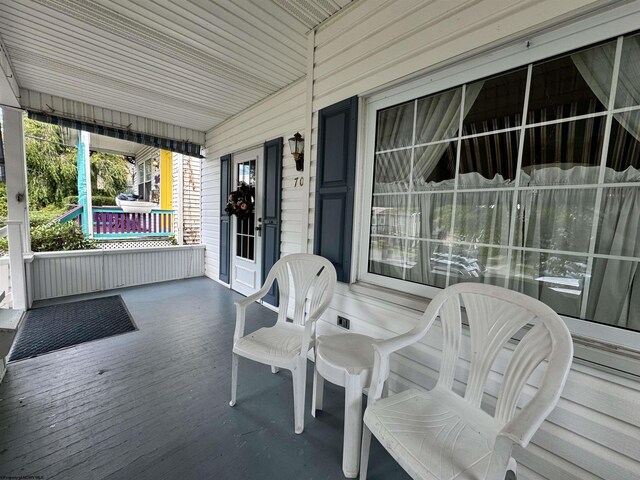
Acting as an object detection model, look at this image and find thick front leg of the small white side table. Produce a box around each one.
[342,376,362,478]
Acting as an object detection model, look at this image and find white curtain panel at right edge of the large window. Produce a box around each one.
[571,40,640,330]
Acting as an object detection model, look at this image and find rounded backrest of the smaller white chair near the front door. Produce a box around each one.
[265,253,336,325]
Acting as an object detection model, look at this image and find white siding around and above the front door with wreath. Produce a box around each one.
[202,79,309,280]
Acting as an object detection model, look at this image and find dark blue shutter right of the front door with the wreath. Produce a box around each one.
[262,137,282,307]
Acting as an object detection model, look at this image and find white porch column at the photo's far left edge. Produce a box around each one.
[2,106,31,310]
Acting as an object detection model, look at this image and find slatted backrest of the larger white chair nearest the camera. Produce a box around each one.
[423,283,573,445]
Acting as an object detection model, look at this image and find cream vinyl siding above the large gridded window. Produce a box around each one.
[313,0,615,111]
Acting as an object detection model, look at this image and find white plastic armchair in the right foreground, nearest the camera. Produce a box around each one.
[360,283,573,480]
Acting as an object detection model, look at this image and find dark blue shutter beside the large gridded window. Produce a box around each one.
[313,97,358,283]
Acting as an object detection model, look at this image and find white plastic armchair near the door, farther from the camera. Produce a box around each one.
[229,253,336,433]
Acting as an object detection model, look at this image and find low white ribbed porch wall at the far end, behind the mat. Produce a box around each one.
[30,245,205,300]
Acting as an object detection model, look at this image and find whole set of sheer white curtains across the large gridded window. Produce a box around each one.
[370,35,640,331]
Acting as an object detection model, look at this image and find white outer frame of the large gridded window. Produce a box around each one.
[354,4,640,351]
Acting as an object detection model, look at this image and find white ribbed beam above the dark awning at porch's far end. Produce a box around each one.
[20,88,204,145]
